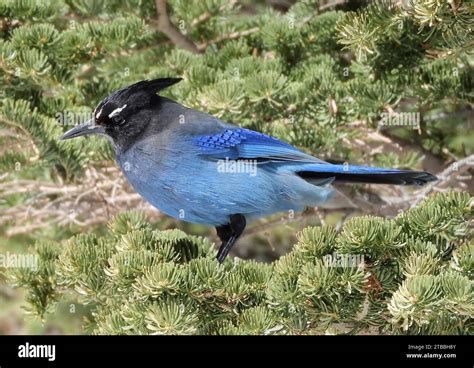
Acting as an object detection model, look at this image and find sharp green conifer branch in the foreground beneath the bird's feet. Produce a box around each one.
[10,192,474,335]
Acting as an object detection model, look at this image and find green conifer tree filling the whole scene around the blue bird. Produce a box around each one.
[0,0,474,334]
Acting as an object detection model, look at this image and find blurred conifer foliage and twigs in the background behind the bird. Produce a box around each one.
[0,0,474,333]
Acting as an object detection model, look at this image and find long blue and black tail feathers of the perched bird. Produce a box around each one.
[297,164,438,185]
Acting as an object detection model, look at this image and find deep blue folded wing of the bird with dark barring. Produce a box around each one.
[193,128,324,163]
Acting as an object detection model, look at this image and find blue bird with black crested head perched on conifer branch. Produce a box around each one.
[60,78,437,263]
